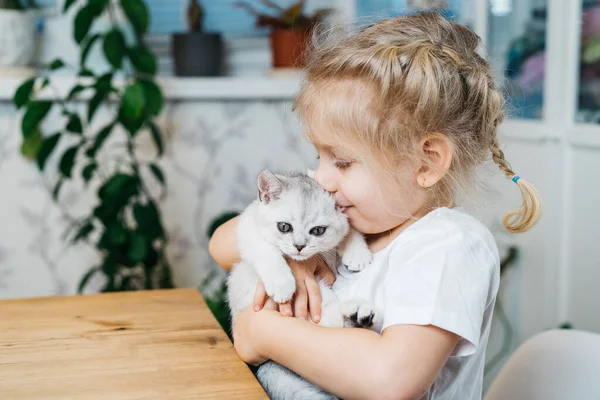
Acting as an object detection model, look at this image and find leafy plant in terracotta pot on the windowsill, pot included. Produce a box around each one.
[235,0,332,68]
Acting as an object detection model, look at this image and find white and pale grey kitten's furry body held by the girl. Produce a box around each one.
[228,170,378,400]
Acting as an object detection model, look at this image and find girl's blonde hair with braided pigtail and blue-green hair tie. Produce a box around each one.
[294,12,541,232]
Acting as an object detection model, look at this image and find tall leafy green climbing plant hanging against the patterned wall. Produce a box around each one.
[13,0,173,292]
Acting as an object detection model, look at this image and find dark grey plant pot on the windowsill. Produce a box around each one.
[171,32,223,76]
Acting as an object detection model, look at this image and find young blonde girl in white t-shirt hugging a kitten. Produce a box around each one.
[210,13,540,400]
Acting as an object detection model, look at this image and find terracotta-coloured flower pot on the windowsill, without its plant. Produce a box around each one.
[271,28,311,68]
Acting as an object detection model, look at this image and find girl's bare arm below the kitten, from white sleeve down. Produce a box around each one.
[234,309,459,400]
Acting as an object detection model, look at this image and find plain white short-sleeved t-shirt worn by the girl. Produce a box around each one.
[333,208,500,400]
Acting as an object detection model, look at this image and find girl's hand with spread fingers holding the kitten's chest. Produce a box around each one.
[252,257,335,322]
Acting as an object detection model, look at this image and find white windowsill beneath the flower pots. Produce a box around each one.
[0,75,301,102]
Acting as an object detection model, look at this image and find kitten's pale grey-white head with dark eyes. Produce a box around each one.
[258,170,350,260]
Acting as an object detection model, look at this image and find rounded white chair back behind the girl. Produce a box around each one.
[484,330,600,400]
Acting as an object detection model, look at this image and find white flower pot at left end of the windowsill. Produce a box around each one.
[0,0,36,69]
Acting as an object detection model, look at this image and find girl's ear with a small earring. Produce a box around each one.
[417,133,453,188]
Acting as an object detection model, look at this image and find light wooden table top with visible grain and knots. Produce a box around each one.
[0,289,267,400]
